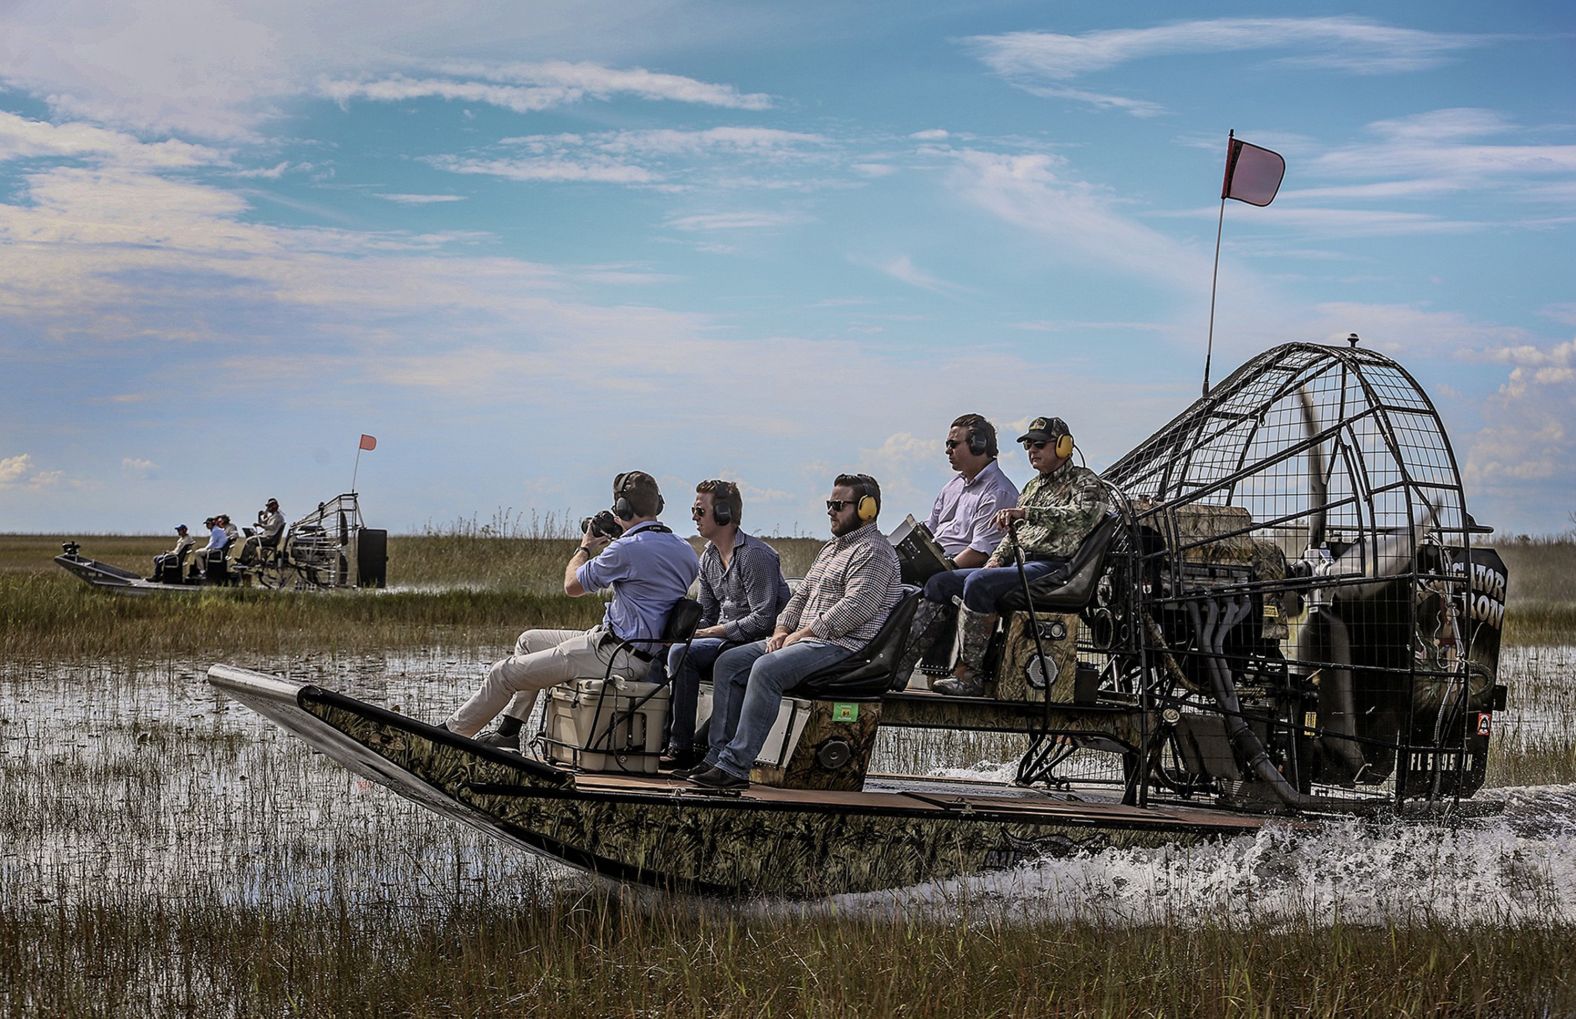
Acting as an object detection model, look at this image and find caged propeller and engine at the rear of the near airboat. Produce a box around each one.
[1105,343,1507,810]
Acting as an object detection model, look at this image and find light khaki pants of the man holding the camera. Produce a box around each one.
[449,627,651,736]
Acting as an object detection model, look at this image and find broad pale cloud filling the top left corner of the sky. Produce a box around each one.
[0,0,771,140]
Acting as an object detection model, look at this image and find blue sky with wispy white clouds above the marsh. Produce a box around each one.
[0,0,1576,534]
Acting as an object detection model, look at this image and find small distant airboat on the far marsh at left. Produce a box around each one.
[55,491,388,594]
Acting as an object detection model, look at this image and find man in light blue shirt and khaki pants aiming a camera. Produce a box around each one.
[443,471,697,748]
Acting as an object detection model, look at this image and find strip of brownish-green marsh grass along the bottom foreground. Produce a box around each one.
[0,891,1576,1017]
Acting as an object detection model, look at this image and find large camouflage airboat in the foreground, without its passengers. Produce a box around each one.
[208,343,1507,896]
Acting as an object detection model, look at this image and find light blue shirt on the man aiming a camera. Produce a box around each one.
[575,523,700,652]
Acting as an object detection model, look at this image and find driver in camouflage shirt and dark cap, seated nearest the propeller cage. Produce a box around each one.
[925,417,1111,696]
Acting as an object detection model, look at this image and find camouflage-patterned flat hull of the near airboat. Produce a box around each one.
[208,665,1264,898]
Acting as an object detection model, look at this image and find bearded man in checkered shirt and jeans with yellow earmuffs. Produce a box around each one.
[687,474,901,789]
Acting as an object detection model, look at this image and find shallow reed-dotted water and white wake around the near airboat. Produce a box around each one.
[0,647,1576,925]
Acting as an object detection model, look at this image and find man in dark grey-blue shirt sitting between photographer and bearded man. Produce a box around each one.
[662,480,790,769]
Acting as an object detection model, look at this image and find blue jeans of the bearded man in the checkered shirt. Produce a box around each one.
[706,638,854,778]
